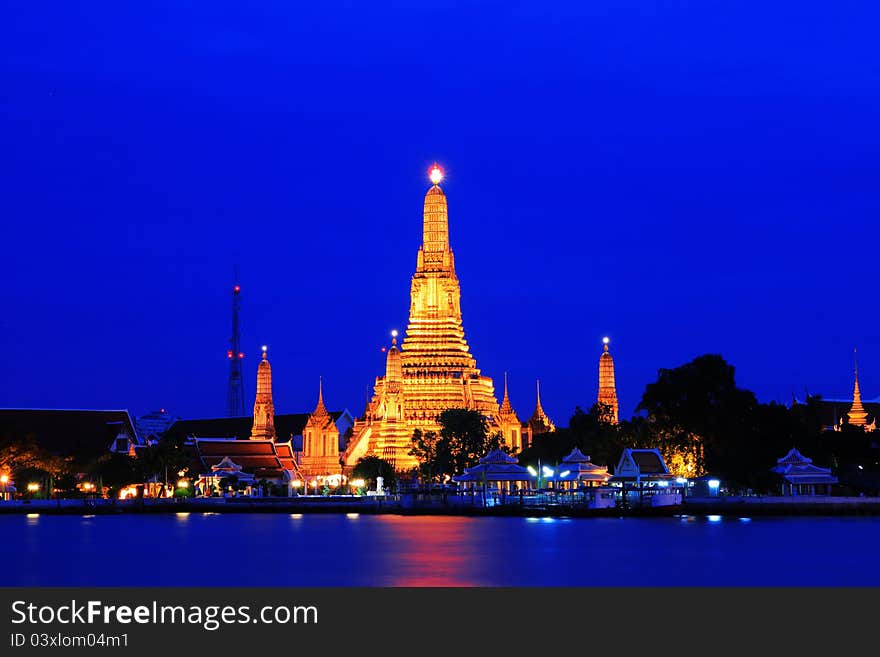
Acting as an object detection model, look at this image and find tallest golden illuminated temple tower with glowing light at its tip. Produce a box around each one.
[344,164,522,470]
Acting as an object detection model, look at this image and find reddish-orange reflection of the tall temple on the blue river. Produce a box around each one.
[372,516,488,586]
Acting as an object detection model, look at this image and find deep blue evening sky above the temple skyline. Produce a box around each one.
[0,0,880,425]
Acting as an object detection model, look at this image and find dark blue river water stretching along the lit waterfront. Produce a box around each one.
[0,513,880,586]
